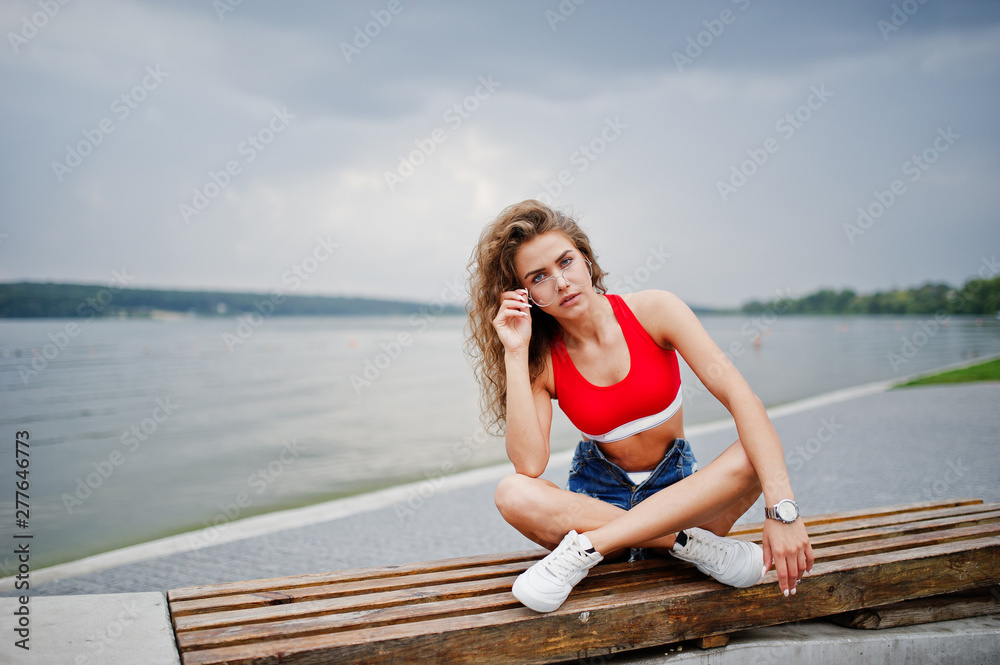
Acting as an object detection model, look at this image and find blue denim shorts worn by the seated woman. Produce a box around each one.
[566,439,698,561]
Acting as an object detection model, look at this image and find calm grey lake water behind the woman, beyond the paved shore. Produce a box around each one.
[0,315,1000,564]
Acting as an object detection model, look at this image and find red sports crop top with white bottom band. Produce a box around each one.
[552,294,681,442]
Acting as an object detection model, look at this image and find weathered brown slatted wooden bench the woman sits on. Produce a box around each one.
[168,499,1000,665]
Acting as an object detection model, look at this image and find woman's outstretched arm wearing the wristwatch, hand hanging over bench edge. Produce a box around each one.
[633,291,813,590]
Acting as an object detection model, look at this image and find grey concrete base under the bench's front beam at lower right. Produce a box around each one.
[616,614,1000,665]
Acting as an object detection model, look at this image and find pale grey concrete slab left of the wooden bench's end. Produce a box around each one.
[0,592,180,665]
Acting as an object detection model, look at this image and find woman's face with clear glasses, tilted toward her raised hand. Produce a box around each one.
[514,231,594,316]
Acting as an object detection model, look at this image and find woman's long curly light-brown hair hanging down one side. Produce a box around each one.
[465,199,606,434]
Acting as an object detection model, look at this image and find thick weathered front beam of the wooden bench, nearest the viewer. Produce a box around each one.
[174,537,1000,665]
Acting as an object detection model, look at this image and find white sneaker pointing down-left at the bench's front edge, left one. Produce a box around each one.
[512,531,604,612]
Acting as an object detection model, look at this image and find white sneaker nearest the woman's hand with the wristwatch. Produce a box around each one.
[670,528,765,587]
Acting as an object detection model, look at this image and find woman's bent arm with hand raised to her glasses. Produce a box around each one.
[493,289,552,478]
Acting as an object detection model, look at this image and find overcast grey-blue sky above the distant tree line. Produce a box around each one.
[0,0,1000,306]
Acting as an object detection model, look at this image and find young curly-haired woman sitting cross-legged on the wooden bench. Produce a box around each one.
[467,200,813,612]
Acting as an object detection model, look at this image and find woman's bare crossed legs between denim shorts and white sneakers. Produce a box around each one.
[496,440,760,557]
